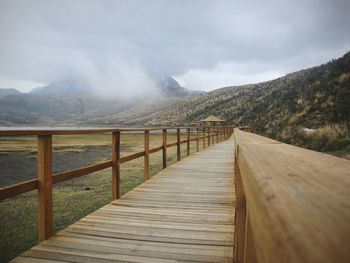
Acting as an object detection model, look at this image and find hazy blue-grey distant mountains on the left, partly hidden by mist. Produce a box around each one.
[0,77,202,126]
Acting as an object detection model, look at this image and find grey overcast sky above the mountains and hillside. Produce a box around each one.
[0,0,350,91]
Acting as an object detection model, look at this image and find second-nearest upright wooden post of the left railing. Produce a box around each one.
[112,131,120,200]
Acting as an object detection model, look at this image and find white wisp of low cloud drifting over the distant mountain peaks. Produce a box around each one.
[72,54,158,100]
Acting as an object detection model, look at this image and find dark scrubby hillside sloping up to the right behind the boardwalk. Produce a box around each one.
[129,53,350,153]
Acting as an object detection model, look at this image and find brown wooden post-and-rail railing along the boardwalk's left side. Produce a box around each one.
[0,126,233,241]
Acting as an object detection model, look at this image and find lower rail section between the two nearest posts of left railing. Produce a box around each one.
[52,161,113,184]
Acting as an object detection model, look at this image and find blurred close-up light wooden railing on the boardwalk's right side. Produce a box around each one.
[234,129,350,263]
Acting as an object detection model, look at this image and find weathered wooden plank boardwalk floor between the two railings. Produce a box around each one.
[12,139,235,263]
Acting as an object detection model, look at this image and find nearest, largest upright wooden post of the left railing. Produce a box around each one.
[38,135,53,242]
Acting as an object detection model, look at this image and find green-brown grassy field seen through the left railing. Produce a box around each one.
[0,134,202,262]
